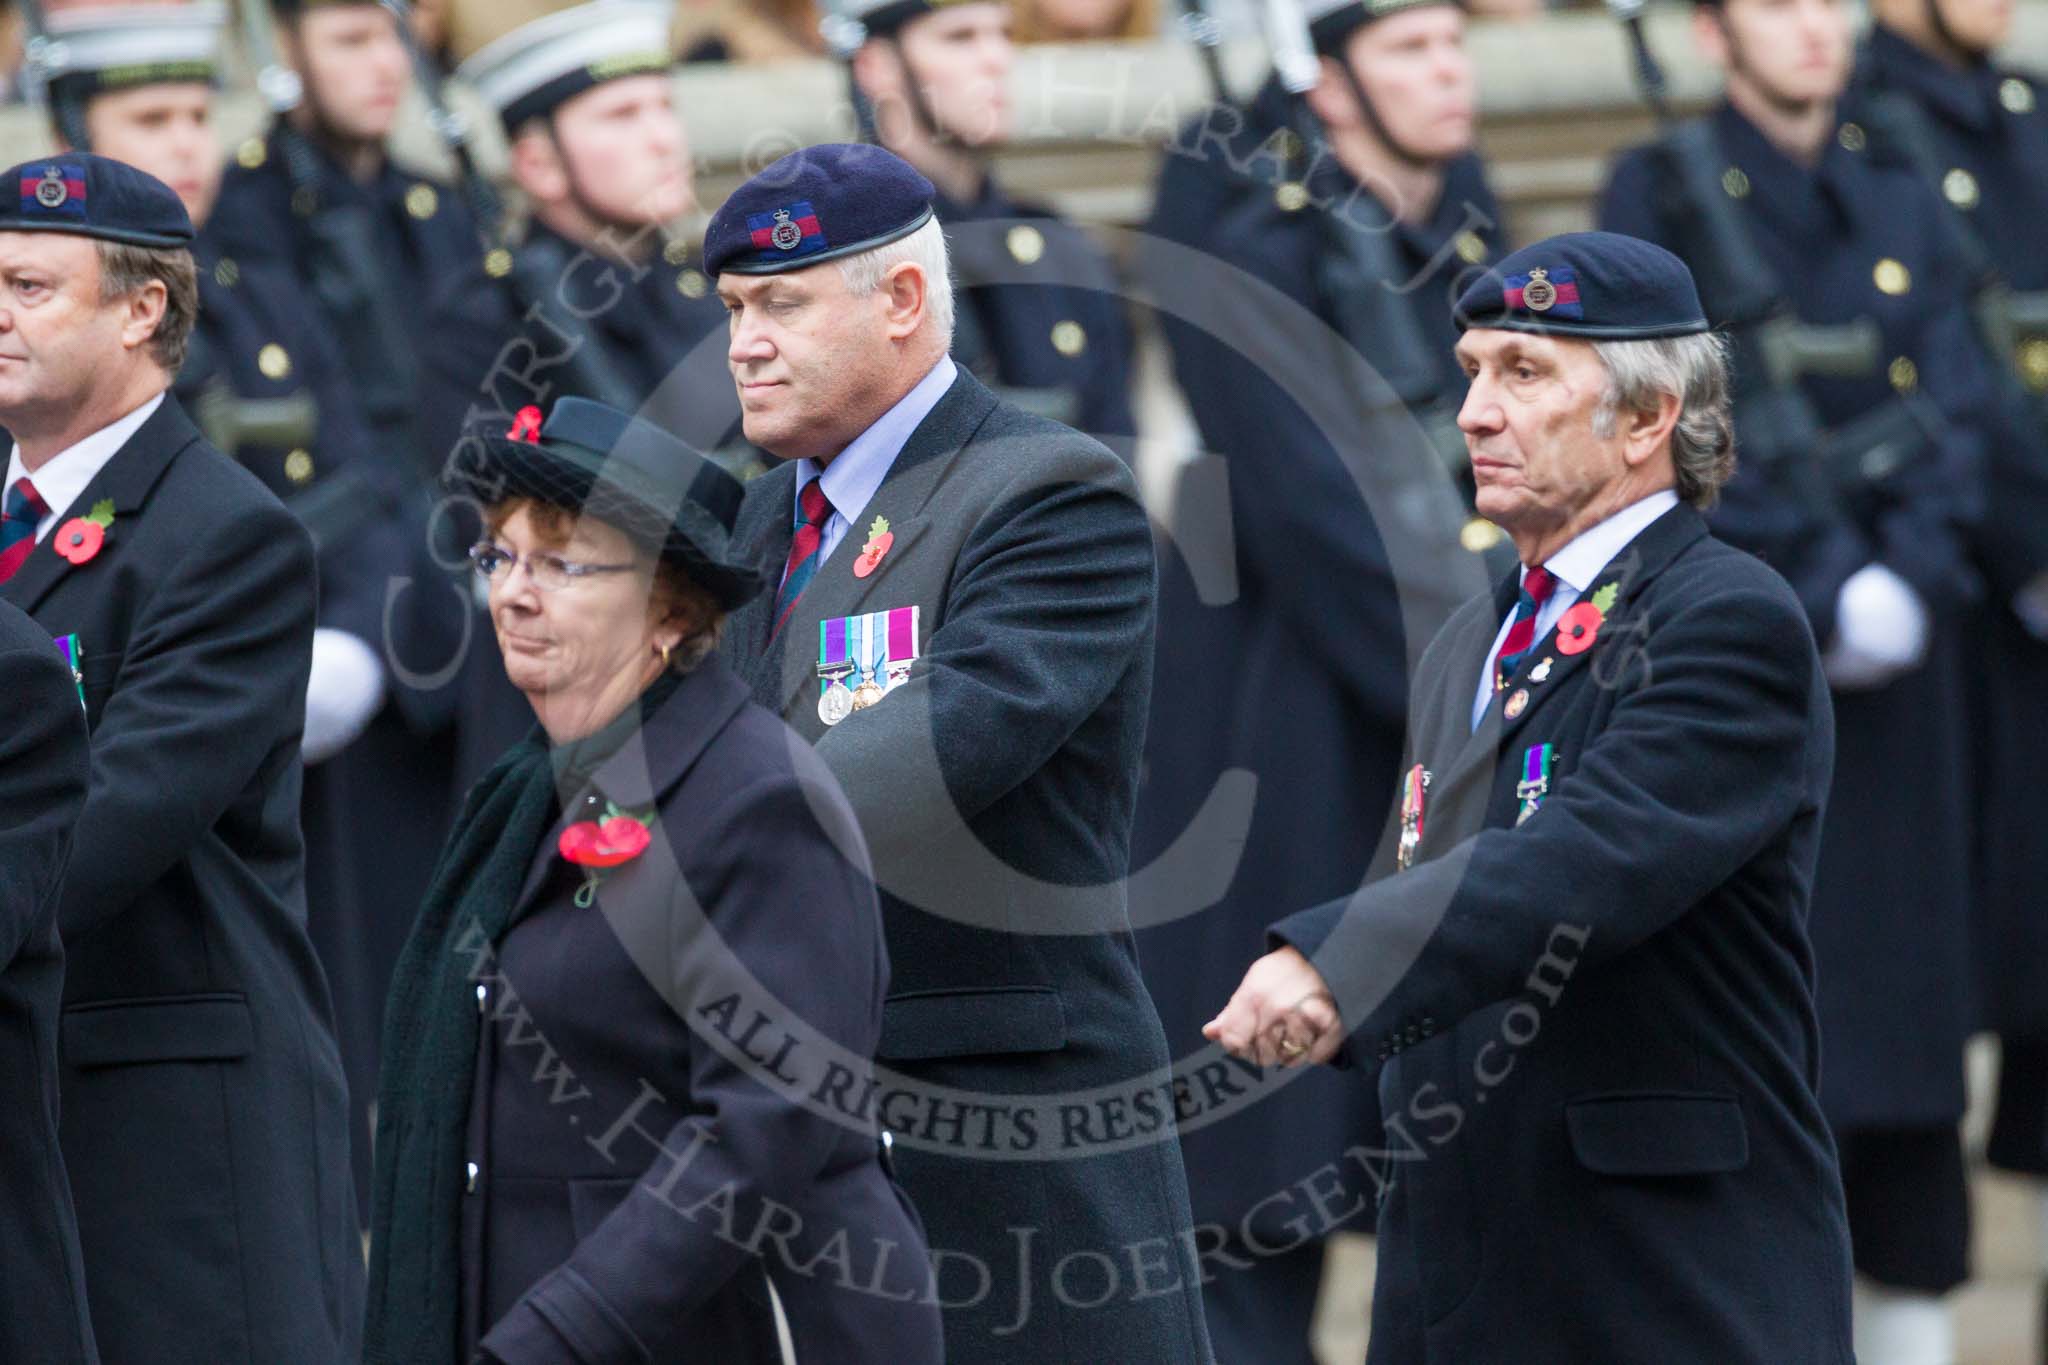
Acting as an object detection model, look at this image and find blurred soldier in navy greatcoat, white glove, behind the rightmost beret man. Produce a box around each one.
[1599,0,1990,1365]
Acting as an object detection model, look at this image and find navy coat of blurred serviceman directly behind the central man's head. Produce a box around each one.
[932,174,1137,444]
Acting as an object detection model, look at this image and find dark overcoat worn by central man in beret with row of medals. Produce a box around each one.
[725,368,1208,1365]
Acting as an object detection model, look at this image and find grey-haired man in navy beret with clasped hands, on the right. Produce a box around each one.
[1206,233,1851,1365]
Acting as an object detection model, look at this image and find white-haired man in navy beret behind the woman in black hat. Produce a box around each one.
[705,145,1210,1365]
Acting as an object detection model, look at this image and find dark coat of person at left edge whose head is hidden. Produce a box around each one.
[0,602,98,1365]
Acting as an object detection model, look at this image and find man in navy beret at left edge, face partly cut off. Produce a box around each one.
[0,153,362,1365]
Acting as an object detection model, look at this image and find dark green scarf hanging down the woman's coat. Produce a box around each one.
[362,673,682,1365]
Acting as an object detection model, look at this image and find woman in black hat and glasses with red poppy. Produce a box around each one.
[365,399,940,1365]
